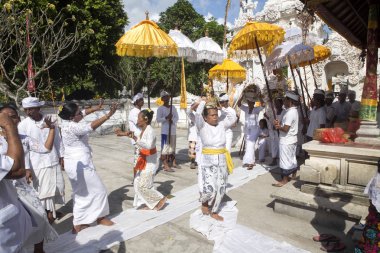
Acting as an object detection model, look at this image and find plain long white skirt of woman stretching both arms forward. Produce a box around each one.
[65,154,109,226]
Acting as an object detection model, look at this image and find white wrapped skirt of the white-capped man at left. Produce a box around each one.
[33,164,65,218]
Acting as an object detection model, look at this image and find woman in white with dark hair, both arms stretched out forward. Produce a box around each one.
[58,101,117,233]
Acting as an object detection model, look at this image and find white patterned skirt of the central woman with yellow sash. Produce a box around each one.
[198,154,228,213]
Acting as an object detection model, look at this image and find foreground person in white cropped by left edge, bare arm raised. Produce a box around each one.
[0,113,32,253]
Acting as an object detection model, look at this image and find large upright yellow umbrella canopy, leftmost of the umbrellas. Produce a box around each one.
[115,20,178,58]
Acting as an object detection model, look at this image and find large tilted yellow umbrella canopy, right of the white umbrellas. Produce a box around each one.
[229,22,285,54]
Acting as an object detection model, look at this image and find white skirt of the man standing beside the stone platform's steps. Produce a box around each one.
[279,143,298,176]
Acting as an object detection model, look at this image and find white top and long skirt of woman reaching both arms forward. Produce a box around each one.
[61,120,109,226]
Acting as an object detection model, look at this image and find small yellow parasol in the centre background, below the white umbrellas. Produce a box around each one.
[208,59,246,93]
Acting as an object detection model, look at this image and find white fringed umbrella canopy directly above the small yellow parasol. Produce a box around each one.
[188,35,223,63]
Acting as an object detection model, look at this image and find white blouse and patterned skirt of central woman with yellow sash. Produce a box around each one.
[195,101,236,213]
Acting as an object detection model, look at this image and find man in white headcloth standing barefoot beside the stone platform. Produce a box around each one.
[273,91,299,187]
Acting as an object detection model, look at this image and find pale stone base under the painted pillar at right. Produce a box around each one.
[355,121,380,144]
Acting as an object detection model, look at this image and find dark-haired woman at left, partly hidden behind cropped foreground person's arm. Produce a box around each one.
[0,105,58,253]
